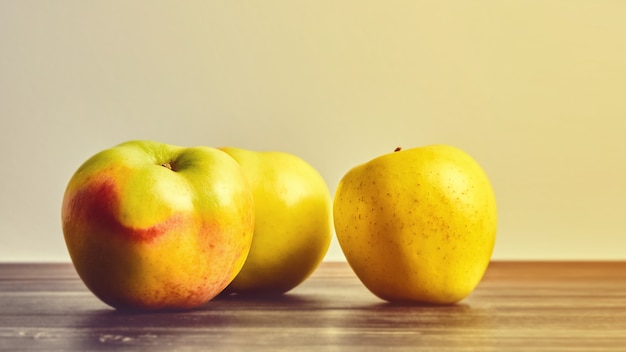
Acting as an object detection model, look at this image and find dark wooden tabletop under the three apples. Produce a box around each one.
[0,262,626,352]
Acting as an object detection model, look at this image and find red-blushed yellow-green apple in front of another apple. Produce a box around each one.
[61,141,254,310]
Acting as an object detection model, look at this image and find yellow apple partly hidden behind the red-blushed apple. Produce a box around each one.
[220,147,332,294]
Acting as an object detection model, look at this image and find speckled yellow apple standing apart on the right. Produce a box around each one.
[333,145,497,304]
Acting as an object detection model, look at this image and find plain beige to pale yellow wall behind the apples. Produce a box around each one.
[0,0,626,261]
